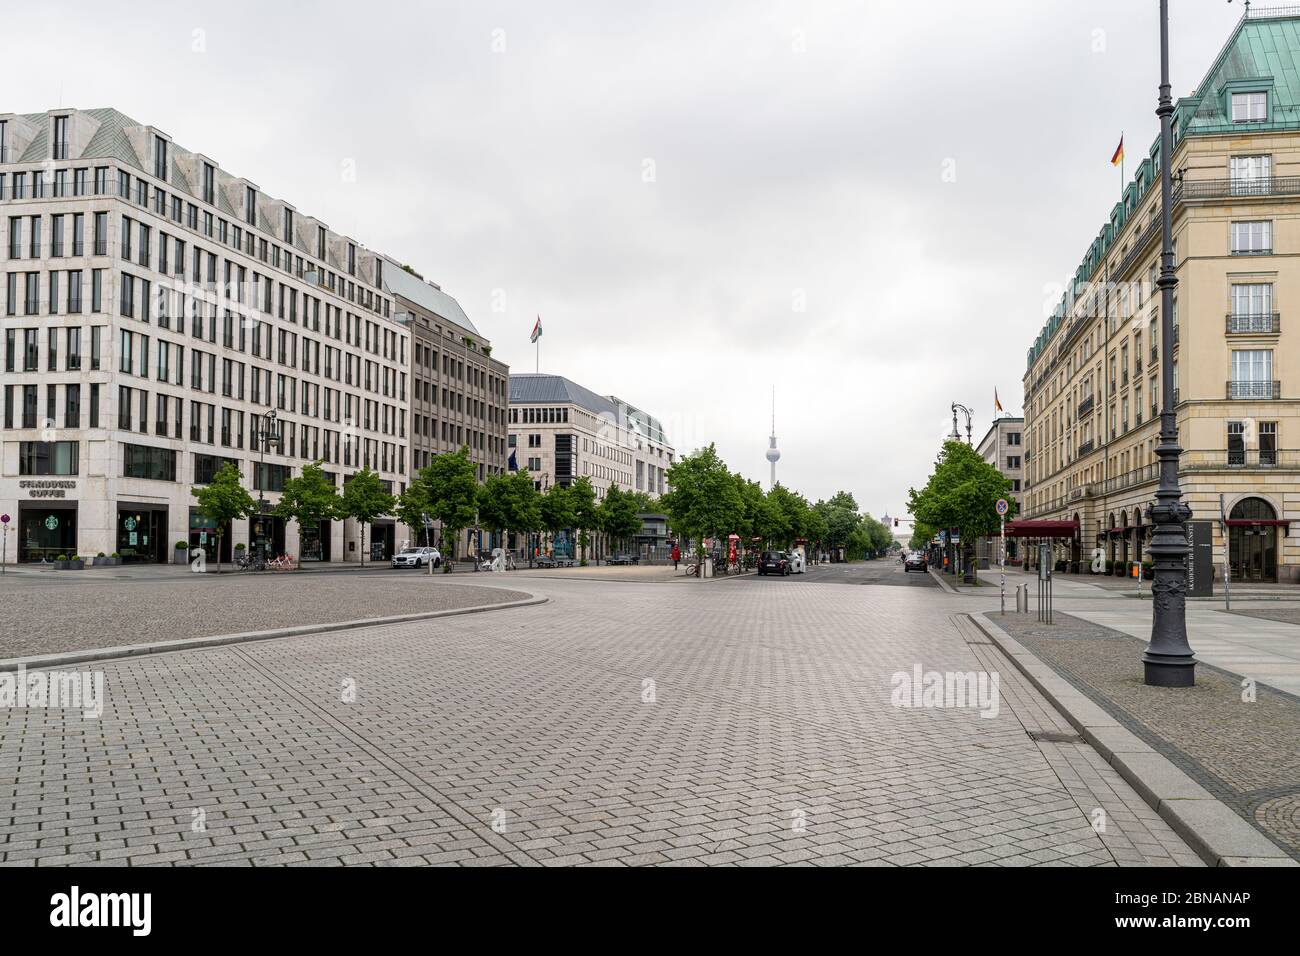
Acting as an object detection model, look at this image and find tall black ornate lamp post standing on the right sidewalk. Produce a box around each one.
[1143,0,1196,687]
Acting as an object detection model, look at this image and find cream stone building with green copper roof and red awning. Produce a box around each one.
[1024,8,1300,580]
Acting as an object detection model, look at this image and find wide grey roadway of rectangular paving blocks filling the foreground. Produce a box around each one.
[0,579,1199,866]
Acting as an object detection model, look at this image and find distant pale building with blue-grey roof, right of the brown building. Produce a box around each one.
[507,372,676,557]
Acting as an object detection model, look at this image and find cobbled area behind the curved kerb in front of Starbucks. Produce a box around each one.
[0,571,528,659]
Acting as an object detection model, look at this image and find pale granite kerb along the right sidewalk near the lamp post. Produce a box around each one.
[967,614,1300,866]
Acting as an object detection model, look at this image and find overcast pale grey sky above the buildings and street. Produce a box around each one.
[0,0,1242,515]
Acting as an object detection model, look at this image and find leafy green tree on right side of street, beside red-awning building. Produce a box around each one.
[907,441,1015,579]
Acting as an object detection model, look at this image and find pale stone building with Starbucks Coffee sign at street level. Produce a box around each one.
[0,109,488,561]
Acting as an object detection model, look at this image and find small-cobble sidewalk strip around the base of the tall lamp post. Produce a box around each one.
[989,611,1300,858]
